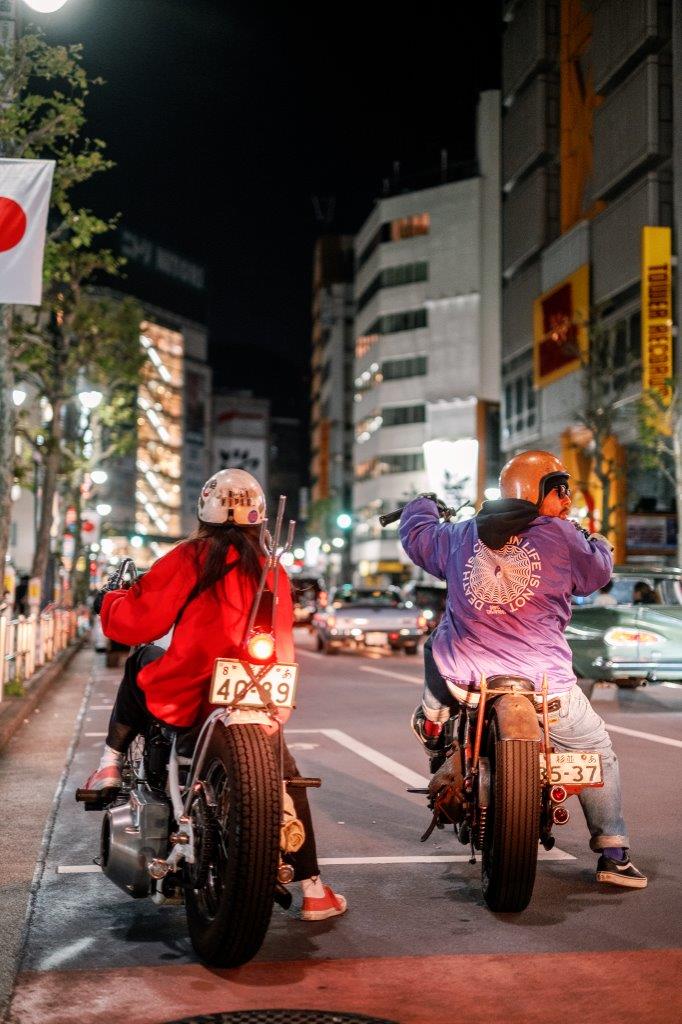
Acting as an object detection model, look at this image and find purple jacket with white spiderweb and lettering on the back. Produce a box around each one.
[400,498,613,693]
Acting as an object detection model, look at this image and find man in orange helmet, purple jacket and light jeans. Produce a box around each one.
[400,452,646,889]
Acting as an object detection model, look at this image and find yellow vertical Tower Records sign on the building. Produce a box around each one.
[642,227,673,404]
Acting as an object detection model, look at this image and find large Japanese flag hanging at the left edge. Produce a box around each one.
[0,160,54,306]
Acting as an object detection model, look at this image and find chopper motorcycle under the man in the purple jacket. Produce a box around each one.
[379,501,603,913]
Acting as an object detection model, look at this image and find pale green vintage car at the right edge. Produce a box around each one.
[566,565,682,687]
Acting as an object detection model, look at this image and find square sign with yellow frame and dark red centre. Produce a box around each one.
[534,263,590,387]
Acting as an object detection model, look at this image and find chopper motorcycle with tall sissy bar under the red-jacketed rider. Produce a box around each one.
[76,497,321,968]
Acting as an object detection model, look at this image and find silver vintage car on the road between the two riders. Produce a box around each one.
[312,584,426,654]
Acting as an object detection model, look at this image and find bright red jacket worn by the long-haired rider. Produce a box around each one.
[101,542,294,726]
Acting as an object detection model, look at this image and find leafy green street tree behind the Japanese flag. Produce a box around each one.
[0,34,142,579]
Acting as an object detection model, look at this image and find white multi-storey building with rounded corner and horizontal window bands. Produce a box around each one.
[352,91,500,583]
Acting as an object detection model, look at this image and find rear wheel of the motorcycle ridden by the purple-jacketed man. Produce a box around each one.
[481,712,541,913]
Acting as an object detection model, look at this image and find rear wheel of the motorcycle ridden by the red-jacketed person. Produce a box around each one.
[185,724,282,967]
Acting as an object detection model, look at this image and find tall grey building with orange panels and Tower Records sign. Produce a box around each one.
[502,0,682,559]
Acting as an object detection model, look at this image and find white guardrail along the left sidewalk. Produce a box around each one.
[0,608,81,700]
